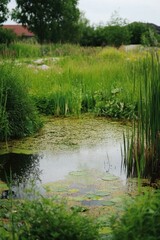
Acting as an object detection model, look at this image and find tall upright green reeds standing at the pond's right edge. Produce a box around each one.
[124,53,160,182]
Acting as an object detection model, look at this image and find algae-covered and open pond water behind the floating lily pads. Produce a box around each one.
[0,117,126,194]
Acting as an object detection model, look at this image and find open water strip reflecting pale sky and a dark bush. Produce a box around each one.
[0,144,126,187]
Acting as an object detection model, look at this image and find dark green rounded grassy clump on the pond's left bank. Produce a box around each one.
[0,64,40,140]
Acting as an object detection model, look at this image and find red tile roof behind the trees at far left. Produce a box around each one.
[2,25,35,37]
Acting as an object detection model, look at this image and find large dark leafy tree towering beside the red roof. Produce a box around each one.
[12,0,80,43]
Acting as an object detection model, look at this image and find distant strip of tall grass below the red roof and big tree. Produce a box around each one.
[0,41,99,59]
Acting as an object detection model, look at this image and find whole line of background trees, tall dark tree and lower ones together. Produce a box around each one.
[0,0,160,47]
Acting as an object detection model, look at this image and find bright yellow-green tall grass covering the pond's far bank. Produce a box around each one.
[17,45,142,118]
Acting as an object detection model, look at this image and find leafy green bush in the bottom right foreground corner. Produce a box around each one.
[112,192,160,240]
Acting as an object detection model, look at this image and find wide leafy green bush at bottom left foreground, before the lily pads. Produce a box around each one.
[2,198,99,240]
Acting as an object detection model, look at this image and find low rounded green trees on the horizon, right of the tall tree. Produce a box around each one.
[80,22,160,47]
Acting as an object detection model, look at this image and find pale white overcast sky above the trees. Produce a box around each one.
[7,0,160,26]
